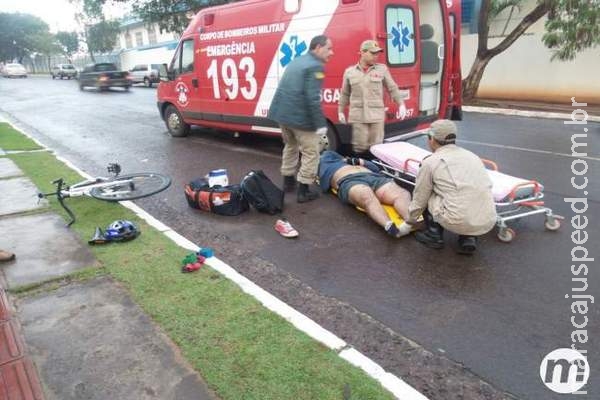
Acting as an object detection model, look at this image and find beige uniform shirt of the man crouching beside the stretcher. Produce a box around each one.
[408,144,496,236]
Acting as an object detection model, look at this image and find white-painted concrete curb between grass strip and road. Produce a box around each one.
[0,115,427,400]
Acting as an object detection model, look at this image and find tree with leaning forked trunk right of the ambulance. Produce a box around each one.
[462,0,600,100]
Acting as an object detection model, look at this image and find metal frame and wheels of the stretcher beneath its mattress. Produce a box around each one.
[372,158,564,243]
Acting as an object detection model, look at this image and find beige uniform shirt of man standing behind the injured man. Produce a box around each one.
[338,64,407,123]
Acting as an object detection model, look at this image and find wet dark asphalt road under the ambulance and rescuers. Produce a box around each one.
[0,76,600,399]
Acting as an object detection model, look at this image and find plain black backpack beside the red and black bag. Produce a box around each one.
[240,170,283,215]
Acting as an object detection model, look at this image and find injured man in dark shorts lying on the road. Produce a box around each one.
[319,151,412,238]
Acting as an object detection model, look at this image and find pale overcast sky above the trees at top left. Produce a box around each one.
[0,0,129,33]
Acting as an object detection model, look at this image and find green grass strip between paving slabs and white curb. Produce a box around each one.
[9,145,393,400]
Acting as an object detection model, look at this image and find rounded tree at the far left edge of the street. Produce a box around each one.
[0,13,52,62]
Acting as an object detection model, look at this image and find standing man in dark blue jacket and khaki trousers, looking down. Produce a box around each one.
[268,35,333,203]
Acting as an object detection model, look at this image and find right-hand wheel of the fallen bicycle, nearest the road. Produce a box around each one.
[90,172,171,201]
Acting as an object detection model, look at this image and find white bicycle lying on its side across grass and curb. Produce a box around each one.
[38,163,171,226]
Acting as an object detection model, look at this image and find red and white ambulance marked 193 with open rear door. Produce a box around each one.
[157,0,461,151]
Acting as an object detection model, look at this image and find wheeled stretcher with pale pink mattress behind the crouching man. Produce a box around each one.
[371,142,563,242]
